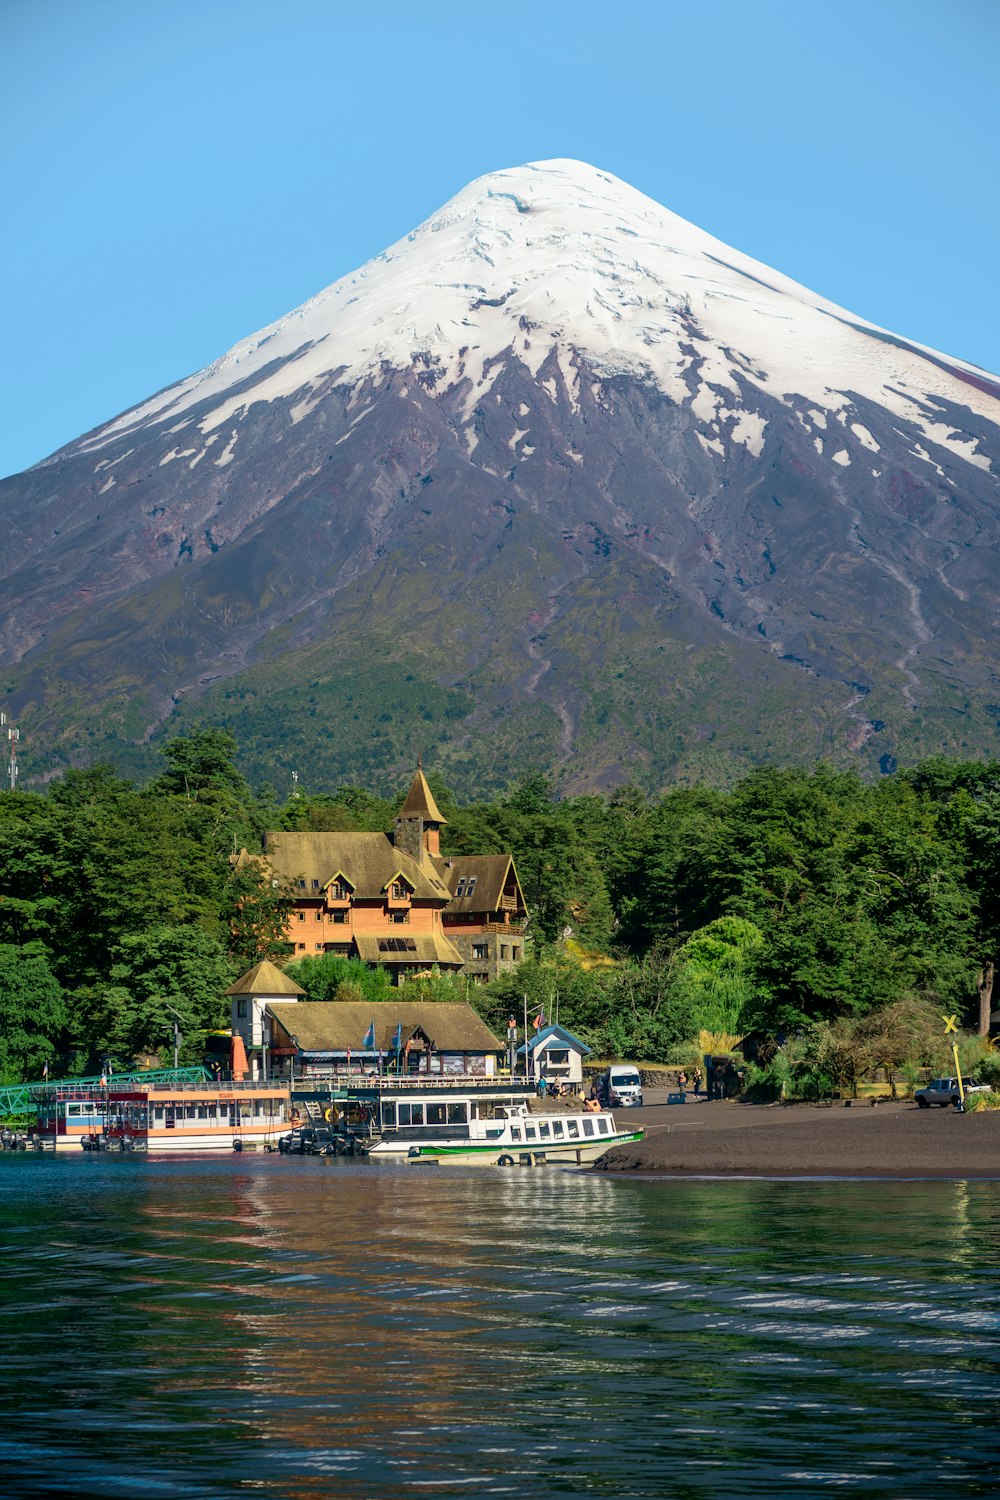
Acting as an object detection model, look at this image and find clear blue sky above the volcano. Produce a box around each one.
[0,0,1000,474]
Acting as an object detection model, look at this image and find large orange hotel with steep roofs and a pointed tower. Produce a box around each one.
[254,768,528,983]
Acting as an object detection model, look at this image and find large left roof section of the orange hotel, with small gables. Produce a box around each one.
[267,833,450,902]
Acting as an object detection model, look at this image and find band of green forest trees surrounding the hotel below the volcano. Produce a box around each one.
[0,728,1000,1083]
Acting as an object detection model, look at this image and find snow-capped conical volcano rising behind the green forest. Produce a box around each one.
[0,161,1000,788]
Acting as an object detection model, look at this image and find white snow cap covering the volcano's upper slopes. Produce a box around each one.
[81,161,1000,468]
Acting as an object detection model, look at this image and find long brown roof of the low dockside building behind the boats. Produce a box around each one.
[267,993,504,1053]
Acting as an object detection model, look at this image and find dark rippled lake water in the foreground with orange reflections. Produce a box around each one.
[0,1152,1000,1500]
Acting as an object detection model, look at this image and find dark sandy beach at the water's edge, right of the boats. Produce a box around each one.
[594,1103,1000,1179]
